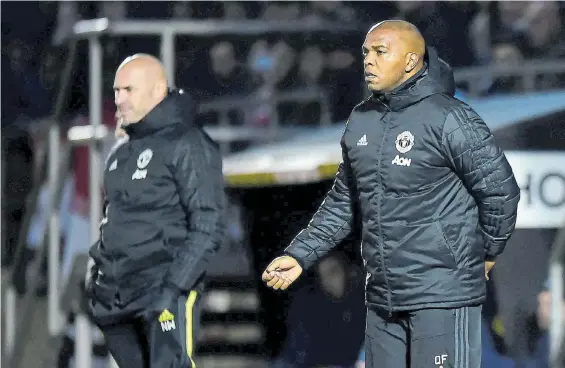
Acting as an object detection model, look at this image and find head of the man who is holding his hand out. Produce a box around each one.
[363,20,426,92]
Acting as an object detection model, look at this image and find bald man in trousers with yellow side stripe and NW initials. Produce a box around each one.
[87,55,226,368]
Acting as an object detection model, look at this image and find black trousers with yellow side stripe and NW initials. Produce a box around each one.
[99,291,200,368]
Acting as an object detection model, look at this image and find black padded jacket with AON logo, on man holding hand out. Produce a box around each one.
[286,48,520,312]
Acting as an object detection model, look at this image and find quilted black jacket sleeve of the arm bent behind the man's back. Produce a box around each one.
[442,106,520,259]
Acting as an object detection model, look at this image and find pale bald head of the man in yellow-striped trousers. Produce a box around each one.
[114,54,167,125]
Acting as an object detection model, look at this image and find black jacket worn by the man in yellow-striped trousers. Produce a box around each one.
[90,92,226,305]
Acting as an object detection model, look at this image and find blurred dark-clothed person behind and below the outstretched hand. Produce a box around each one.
[274,253,365,368]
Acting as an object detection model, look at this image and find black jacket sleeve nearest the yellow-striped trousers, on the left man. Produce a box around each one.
[165,131,226,291]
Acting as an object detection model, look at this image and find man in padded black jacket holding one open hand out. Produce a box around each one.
[263,21,520,368]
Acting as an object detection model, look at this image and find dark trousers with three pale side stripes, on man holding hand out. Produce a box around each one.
[365,306,481,368]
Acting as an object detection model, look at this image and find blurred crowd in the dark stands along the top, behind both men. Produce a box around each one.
[2,1,565,132]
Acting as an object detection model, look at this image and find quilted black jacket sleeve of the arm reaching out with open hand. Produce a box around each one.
[285,141,354,269]
